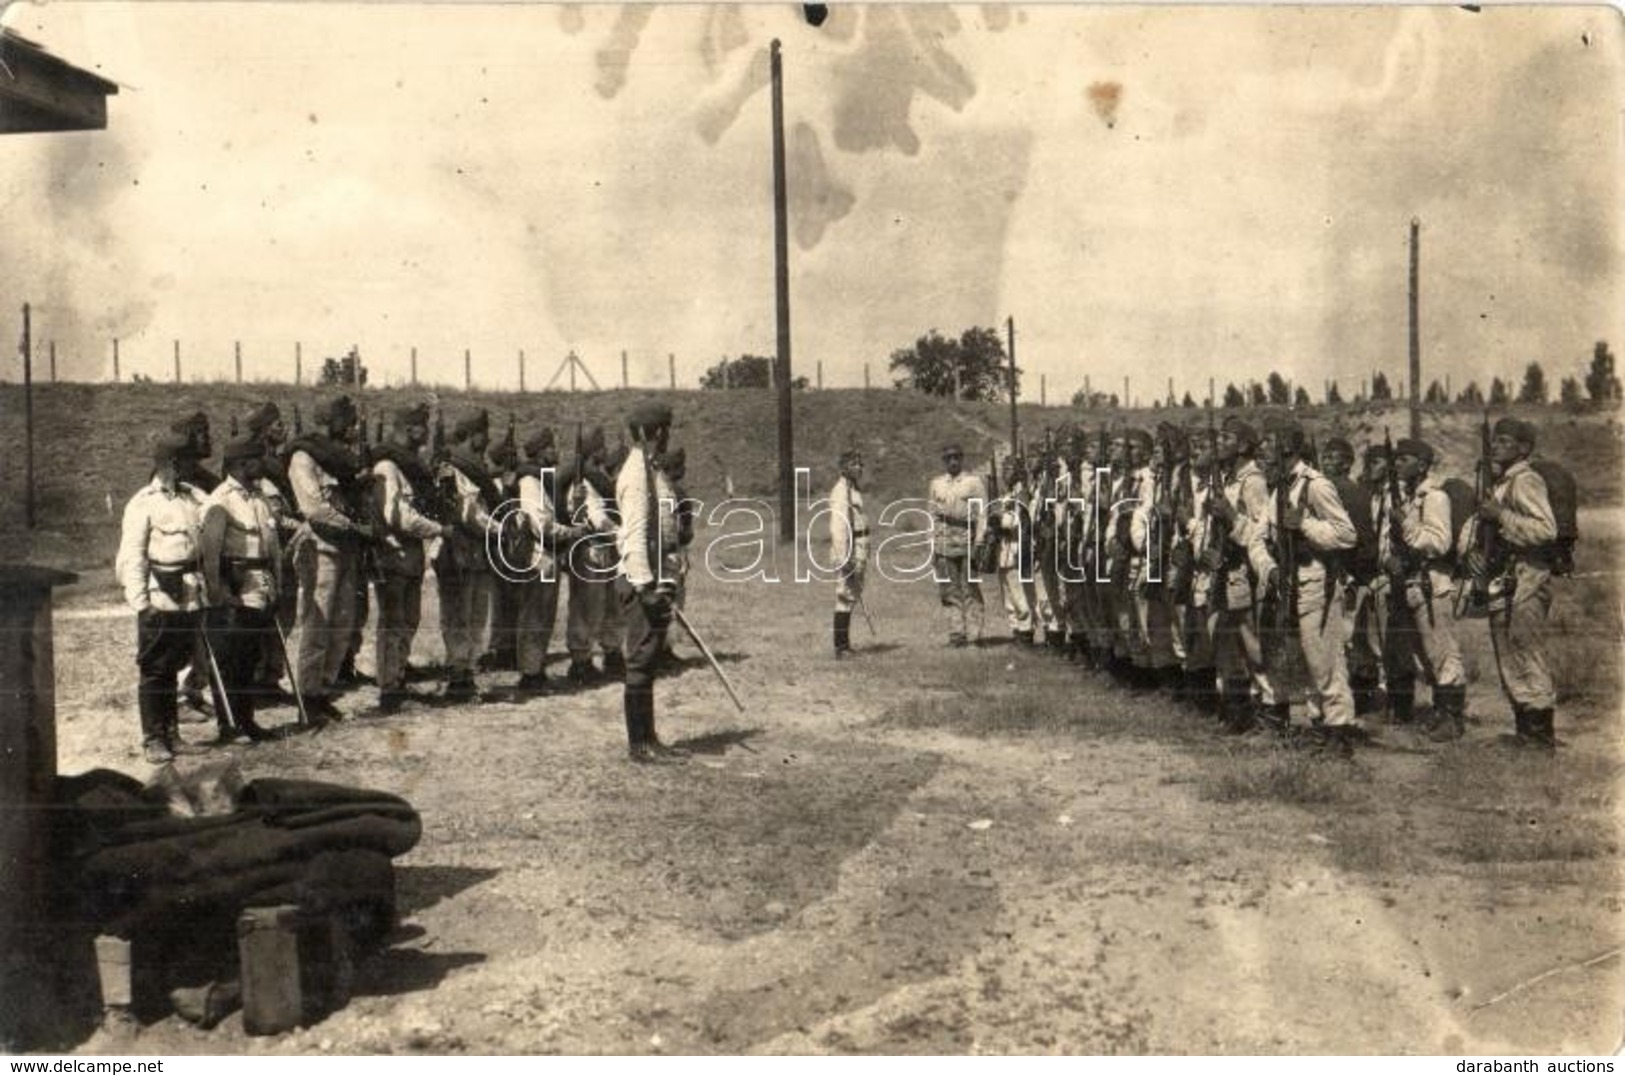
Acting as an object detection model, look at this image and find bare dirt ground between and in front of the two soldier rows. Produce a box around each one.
[47,535,1625,1054]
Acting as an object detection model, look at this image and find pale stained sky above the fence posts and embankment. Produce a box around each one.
[0,0,1625,403]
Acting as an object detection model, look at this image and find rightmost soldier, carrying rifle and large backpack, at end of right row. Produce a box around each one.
[1467,417,1557,750]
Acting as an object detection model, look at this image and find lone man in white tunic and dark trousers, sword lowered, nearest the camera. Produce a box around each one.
[614,403,683,763]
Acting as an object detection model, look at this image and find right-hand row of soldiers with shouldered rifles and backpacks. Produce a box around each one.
[890,414,1575,755]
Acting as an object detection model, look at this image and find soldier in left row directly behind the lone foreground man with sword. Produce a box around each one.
[561,425,624,685]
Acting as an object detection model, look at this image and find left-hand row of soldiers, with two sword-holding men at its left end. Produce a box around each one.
[117,396,692,763]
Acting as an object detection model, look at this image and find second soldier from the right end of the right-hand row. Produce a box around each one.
[1376,438,1467,742]
